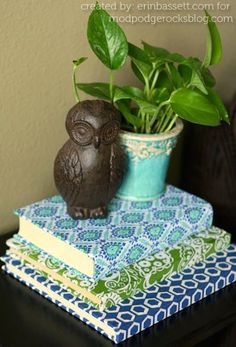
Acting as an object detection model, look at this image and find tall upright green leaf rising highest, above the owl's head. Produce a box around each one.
[87,6,128,70]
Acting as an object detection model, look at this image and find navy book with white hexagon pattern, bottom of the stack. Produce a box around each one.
[2,245,236,343]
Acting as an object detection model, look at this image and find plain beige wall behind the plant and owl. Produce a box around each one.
[0,0,236,233]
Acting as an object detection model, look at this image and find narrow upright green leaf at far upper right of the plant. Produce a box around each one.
[203,11,222,67]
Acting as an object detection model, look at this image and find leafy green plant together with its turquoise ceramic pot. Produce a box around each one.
[73,3,229,201]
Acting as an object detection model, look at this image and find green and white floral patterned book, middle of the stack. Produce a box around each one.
[7,227,231,310]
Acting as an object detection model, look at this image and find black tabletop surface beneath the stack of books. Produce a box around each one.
[0,234,236,347]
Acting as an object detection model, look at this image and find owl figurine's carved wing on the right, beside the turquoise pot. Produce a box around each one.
[109,143,125,199]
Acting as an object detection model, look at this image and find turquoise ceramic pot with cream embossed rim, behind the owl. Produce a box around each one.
[116,119,183,201]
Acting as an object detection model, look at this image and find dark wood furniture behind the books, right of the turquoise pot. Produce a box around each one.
[181,94,236,237]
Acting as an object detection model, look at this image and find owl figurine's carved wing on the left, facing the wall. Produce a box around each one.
[54,146,83,206]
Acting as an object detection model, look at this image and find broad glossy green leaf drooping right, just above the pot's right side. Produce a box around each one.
[170,88,220,126]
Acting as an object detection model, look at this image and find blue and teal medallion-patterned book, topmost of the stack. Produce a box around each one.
[16,186,213,279]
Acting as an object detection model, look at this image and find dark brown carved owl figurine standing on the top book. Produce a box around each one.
[54,100,124,219]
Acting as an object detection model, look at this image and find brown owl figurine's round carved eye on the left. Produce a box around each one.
[71,122,93,146]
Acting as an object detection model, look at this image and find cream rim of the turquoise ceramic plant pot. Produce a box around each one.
[120,119,184,141]
